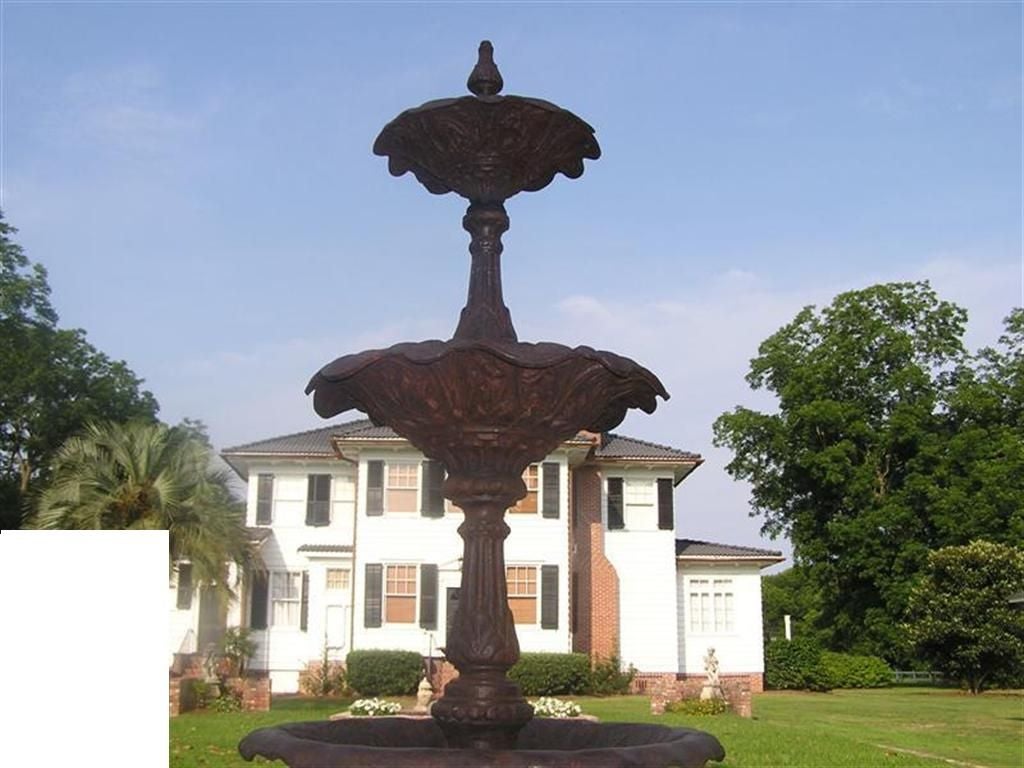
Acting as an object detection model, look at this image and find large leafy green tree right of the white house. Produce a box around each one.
[715,283,1024,662]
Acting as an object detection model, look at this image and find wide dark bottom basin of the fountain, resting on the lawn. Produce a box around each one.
[239,717,725,768]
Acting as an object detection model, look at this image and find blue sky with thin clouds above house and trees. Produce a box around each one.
[2,1,1024,561]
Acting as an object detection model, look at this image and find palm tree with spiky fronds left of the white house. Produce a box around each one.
[26,421,255,592]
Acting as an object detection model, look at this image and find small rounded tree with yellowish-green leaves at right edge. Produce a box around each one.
[907,541,1024,693]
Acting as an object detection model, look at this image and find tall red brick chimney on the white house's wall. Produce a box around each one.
[571,467,618,659]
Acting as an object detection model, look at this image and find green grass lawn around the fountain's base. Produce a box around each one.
[170,688,1024,768]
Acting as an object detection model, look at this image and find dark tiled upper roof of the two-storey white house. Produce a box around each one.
[221,419,701,479]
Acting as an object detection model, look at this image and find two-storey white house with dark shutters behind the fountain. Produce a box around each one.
[171,420,782,692]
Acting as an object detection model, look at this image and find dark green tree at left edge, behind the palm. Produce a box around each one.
[0,217,158,528]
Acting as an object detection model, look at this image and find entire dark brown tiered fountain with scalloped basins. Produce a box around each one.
[239,41,725,768]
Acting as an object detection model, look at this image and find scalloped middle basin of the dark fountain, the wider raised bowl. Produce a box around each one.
[306,339,669,472]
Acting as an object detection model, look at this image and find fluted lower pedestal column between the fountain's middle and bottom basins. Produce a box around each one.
[431,474,534,750]
